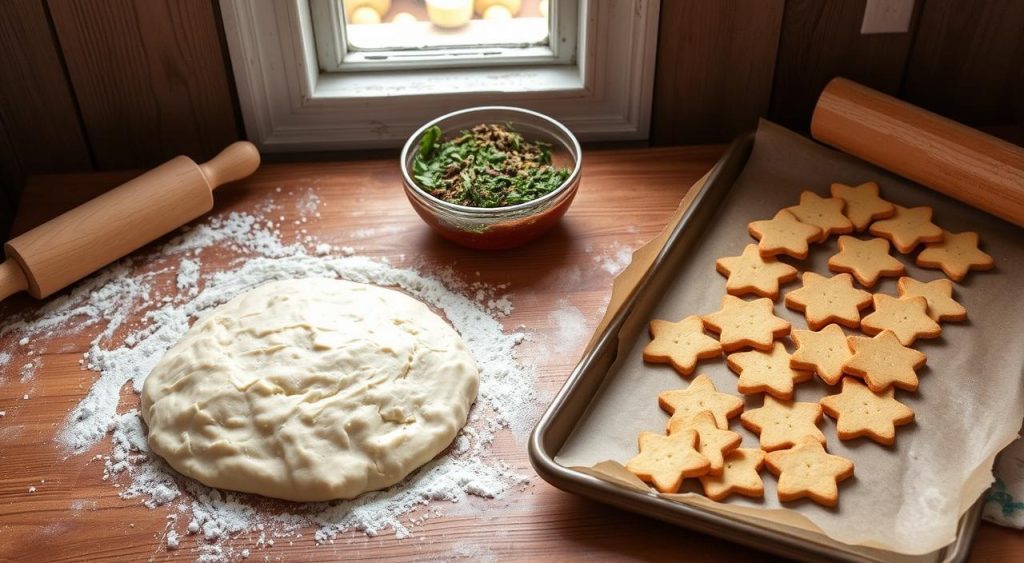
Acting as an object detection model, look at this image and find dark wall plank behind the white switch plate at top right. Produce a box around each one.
[769,0,922,131]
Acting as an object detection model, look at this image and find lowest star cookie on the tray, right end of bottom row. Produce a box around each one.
[765,438,853,507]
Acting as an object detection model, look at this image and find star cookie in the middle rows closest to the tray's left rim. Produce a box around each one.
[643,315,722,376]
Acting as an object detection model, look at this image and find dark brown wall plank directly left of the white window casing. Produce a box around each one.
[49,0,240,169]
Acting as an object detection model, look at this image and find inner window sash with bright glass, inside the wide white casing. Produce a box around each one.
[310,0,579,72]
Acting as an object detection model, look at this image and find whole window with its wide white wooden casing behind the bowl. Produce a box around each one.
[220,0,659,151]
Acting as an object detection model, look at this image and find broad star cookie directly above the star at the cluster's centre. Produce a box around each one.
[785,271,871,331]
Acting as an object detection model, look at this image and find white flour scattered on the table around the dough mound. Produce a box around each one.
[6,195,536,561]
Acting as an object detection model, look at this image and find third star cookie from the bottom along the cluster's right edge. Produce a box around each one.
[843,331,928,393]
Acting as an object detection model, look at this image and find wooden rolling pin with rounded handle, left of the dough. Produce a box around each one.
[0,141,259,301]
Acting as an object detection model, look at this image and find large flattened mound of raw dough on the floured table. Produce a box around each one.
[142,278,479,502]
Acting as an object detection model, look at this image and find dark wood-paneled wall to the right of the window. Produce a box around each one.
[651,0,1024,144]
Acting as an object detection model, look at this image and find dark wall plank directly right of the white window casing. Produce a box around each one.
[651,0,783,144]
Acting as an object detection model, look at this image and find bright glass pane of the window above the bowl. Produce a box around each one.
[342,0,551,55]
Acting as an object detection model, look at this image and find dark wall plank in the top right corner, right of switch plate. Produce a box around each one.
[902,0,1024,125]
